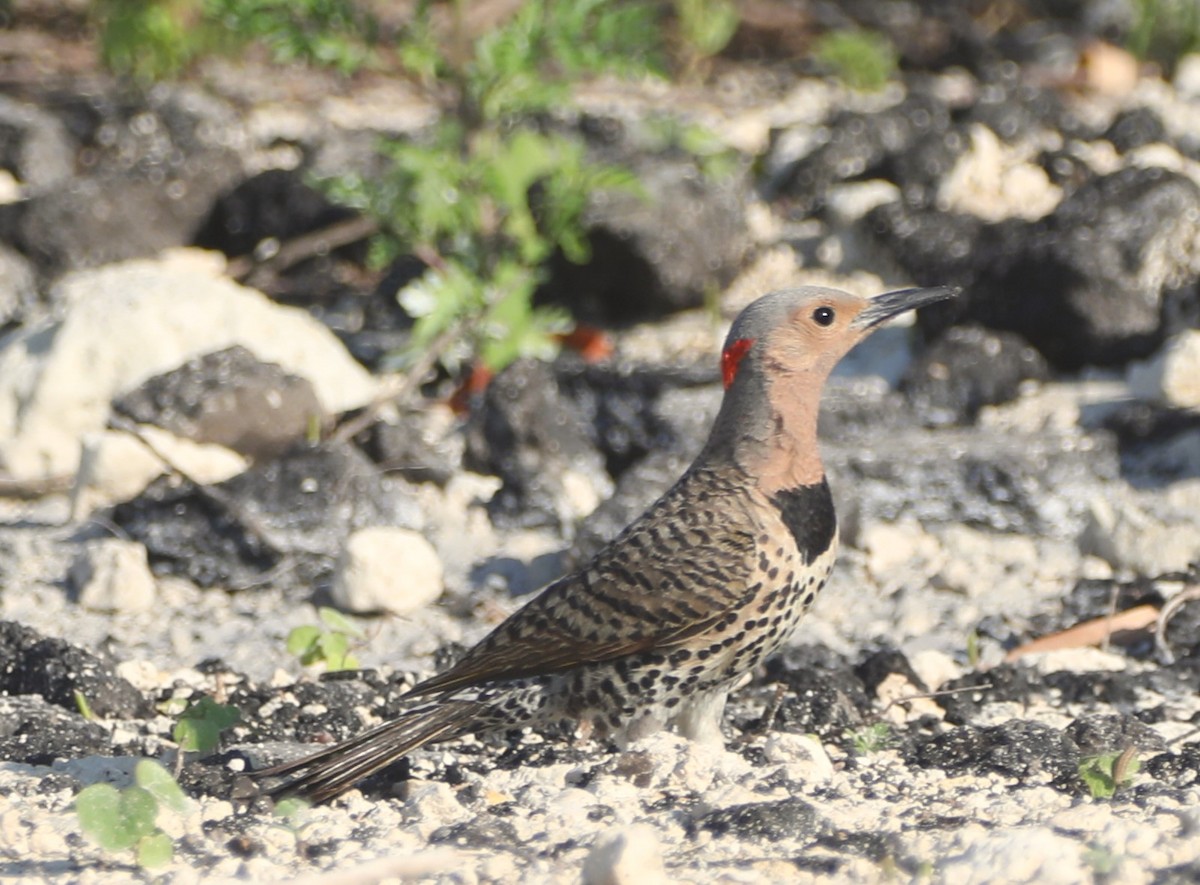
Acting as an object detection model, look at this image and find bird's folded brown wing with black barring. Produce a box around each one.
[410,470,757,694]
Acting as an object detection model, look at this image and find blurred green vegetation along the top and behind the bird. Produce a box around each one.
[9,0,1200,372]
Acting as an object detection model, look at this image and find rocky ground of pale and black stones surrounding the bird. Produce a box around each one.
[0,4,1200,883]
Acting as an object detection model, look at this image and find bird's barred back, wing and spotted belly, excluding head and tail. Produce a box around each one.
[403,465,835,734]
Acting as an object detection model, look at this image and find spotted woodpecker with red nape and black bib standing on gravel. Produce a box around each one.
[253,287,958,802]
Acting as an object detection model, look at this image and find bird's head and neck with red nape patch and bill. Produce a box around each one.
[708,285,958,483]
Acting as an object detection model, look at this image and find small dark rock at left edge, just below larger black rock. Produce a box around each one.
[0,694,113,765]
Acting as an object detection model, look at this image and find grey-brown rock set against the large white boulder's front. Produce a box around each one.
[113,345,324,459]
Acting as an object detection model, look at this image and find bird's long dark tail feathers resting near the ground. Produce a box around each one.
[253,700,484,802]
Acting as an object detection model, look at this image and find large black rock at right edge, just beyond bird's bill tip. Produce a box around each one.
[940,168,1200,369]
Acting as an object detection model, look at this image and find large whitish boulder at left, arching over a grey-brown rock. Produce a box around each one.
[0,249,377,480]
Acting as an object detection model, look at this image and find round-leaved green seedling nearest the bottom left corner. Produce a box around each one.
[76,759,190,869]
